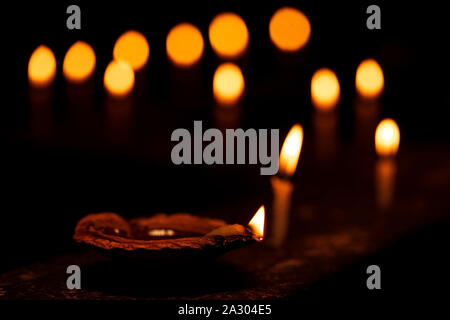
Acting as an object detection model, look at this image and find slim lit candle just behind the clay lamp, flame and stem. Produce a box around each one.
[269,124,303,248]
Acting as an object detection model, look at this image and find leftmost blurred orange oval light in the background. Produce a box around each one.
[28,45,56,87]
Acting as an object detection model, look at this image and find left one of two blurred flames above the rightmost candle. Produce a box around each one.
[311,68,340,111]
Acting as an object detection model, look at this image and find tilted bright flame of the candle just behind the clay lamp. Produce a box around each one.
[279,124,303,176]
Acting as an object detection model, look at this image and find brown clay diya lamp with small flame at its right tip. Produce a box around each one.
[73,206,264,263]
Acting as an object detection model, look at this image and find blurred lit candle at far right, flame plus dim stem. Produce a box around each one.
[375,119,400,210]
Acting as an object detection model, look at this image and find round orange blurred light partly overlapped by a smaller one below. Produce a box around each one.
[113,30,150,71]
